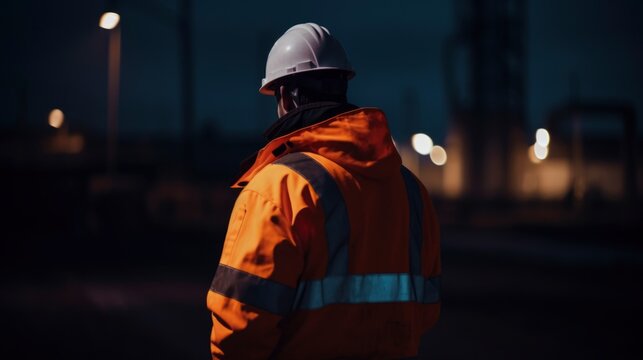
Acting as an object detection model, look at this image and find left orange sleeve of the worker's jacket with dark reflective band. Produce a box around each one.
[207,171,303,359]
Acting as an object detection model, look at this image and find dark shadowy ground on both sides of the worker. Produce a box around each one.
[0,224,643,359]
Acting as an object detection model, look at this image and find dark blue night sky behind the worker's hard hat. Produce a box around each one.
[0,0,643,143]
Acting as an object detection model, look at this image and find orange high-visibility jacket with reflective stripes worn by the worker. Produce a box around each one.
[207,108,440,359]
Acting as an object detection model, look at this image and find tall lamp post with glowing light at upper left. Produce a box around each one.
[99,12,121,175]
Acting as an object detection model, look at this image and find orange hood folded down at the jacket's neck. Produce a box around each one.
[233,108,402,187]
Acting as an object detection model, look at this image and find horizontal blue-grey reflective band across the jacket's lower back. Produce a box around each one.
[293,273,440,310]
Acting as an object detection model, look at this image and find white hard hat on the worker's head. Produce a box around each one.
[259,23,355,95]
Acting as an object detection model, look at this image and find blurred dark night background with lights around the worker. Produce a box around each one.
[0,0,643,359]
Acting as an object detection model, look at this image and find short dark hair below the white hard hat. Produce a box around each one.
[275,70,348,106]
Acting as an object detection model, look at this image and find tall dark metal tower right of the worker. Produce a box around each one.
[444,0,526,199]
